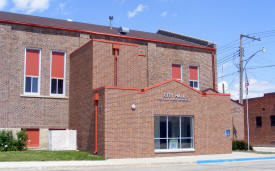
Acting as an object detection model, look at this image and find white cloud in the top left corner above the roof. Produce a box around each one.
[12,0,49,13]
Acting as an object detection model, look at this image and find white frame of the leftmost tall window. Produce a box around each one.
[23,47,41,95]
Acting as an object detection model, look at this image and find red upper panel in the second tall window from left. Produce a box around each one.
[52,52,65,78]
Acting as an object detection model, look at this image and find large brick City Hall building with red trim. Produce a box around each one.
[0,12,245,158]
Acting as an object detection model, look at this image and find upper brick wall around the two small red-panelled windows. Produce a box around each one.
[148,43,217,90]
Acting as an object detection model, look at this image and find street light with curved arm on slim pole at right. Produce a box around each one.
[244,47,266,151]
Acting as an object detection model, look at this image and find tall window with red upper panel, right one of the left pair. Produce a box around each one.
[51,51,65,95]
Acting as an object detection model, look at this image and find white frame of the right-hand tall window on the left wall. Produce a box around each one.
[50,50,67,97]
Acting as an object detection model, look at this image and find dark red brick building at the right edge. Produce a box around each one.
[244,93,275,146]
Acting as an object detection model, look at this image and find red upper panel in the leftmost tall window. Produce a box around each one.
[26,49,39,76]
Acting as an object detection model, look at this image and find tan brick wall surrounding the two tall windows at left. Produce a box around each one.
[0,24,89,128]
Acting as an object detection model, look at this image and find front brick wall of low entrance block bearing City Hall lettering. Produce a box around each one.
[98,82,232,158]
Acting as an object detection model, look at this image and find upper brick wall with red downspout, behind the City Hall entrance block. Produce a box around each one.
[93,41,147,88]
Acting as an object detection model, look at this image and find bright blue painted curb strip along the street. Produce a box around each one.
[197,156,275,164]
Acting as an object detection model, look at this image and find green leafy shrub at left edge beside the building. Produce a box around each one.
[0,130,28,151]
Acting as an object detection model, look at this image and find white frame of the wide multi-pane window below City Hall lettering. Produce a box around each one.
[153,115,195,153]
